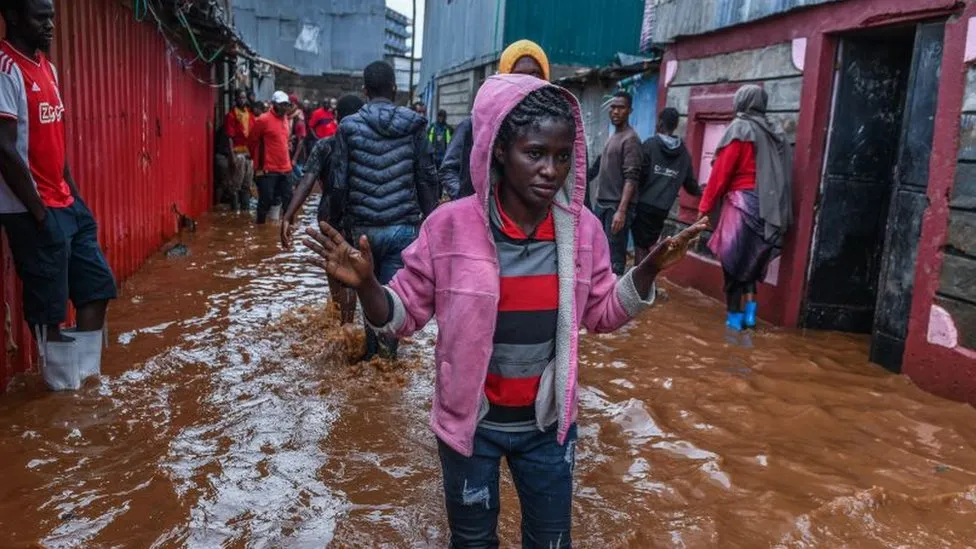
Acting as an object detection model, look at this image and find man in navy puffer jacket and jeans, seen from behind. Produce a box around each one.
[331,61,440,359]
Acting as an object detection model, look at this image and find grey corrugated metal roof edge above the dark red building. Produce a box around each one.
[647,0,843,44]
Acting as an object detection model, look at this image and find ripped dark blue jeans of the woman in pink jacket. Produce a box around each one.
[437,425,577,549]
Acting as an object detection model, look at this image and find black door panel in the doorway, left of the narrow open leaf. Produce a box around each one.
[802,37,913,333]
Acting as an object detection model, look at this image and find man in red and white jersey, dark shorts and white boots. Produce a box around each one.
[0,0,116,390]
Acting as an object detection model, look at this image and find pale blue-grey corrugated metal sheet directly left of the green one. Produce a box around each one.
[420,0,508,88]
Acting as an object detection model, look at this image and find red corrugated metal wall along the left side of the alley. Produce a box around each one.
[0,0,216,389]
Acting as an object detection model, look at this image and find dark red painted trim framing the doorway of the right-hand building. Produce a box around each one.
[658,0,976,404]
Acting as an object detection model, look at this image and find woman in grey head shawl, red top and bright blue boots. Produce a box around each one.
[698,85,793,330]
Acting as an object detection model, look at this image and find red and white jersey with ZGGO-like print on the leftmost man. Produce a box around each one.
[0,40,75,213]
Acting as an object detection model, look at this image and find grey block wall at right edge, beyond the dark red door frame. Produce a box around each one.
[935,66,976,349]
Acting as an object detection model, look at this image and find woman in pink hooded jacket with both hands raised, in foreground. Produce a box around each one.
[306,75,704,548]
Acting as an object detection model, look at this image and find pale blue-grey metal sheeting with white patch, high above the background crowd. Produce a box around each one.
[232,0,386,75]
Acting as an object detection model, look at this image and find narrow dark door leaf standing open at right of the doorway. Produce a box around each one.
[871,21,945,372]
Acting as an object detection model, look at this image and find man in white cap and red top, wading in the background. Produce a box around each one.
[250,91,292,225]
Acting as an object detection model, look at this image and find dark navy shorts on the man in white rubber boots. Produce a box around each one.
[0,199,116,326]
